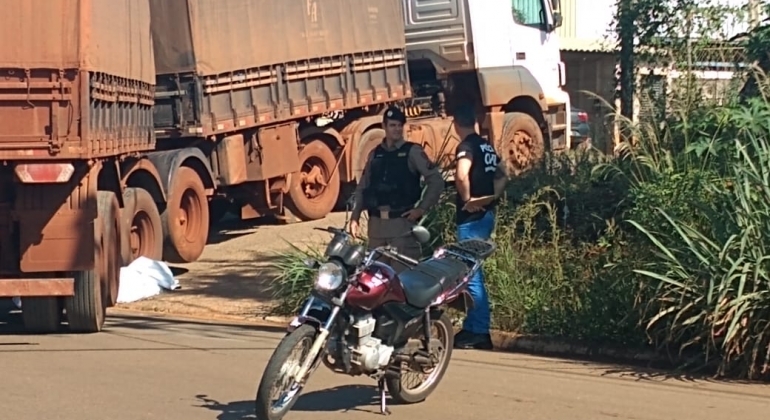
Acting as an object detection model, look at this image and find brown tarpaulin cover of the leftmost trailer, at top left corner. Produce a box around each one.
[0,0,155,85]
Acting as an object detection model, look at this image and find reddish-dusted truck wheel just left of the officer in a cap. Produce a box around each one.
[289,140,340,221]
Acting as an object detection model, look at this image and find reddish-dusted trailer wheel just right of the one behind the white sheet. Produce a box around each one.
[160,166,209,263]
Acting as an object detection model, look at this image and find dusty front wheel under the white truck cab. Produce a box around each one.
[496,112,545,175]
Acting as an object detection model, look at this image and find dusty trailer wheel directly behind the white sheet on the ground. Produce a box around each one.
[121,188,163,265]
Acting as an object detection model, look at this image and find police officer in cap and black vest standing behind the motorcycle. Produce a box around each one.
[350,107,444,271]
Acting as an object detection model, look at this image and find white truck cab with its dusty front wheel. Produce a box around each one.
[403,0,570,171]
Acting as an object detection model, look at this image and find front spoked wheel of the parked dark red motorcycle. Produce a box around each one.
[254,325,316,420]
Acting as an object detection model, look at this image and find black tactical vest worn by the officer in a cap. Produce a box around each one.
[364,142,422,211]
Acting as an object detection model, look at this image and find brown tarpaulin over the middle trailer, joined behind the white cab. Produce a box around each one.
[150,0,404,76]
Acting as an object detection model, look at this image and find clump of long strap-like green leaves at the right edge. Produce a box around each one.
[630,97,770,378]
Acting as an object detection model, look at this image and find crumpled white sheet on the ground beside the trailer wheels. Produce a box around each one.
[118,257,179,303]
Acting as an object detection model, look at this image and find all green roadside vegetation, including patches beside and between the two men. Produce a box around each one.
[266,4,770,379]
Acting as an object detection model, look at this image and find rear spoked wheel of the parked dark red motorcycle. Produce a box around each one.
[385,314,454,404]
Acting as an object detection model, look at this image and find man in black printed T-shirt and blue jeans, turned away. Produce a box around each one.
[454,105,507,349]
